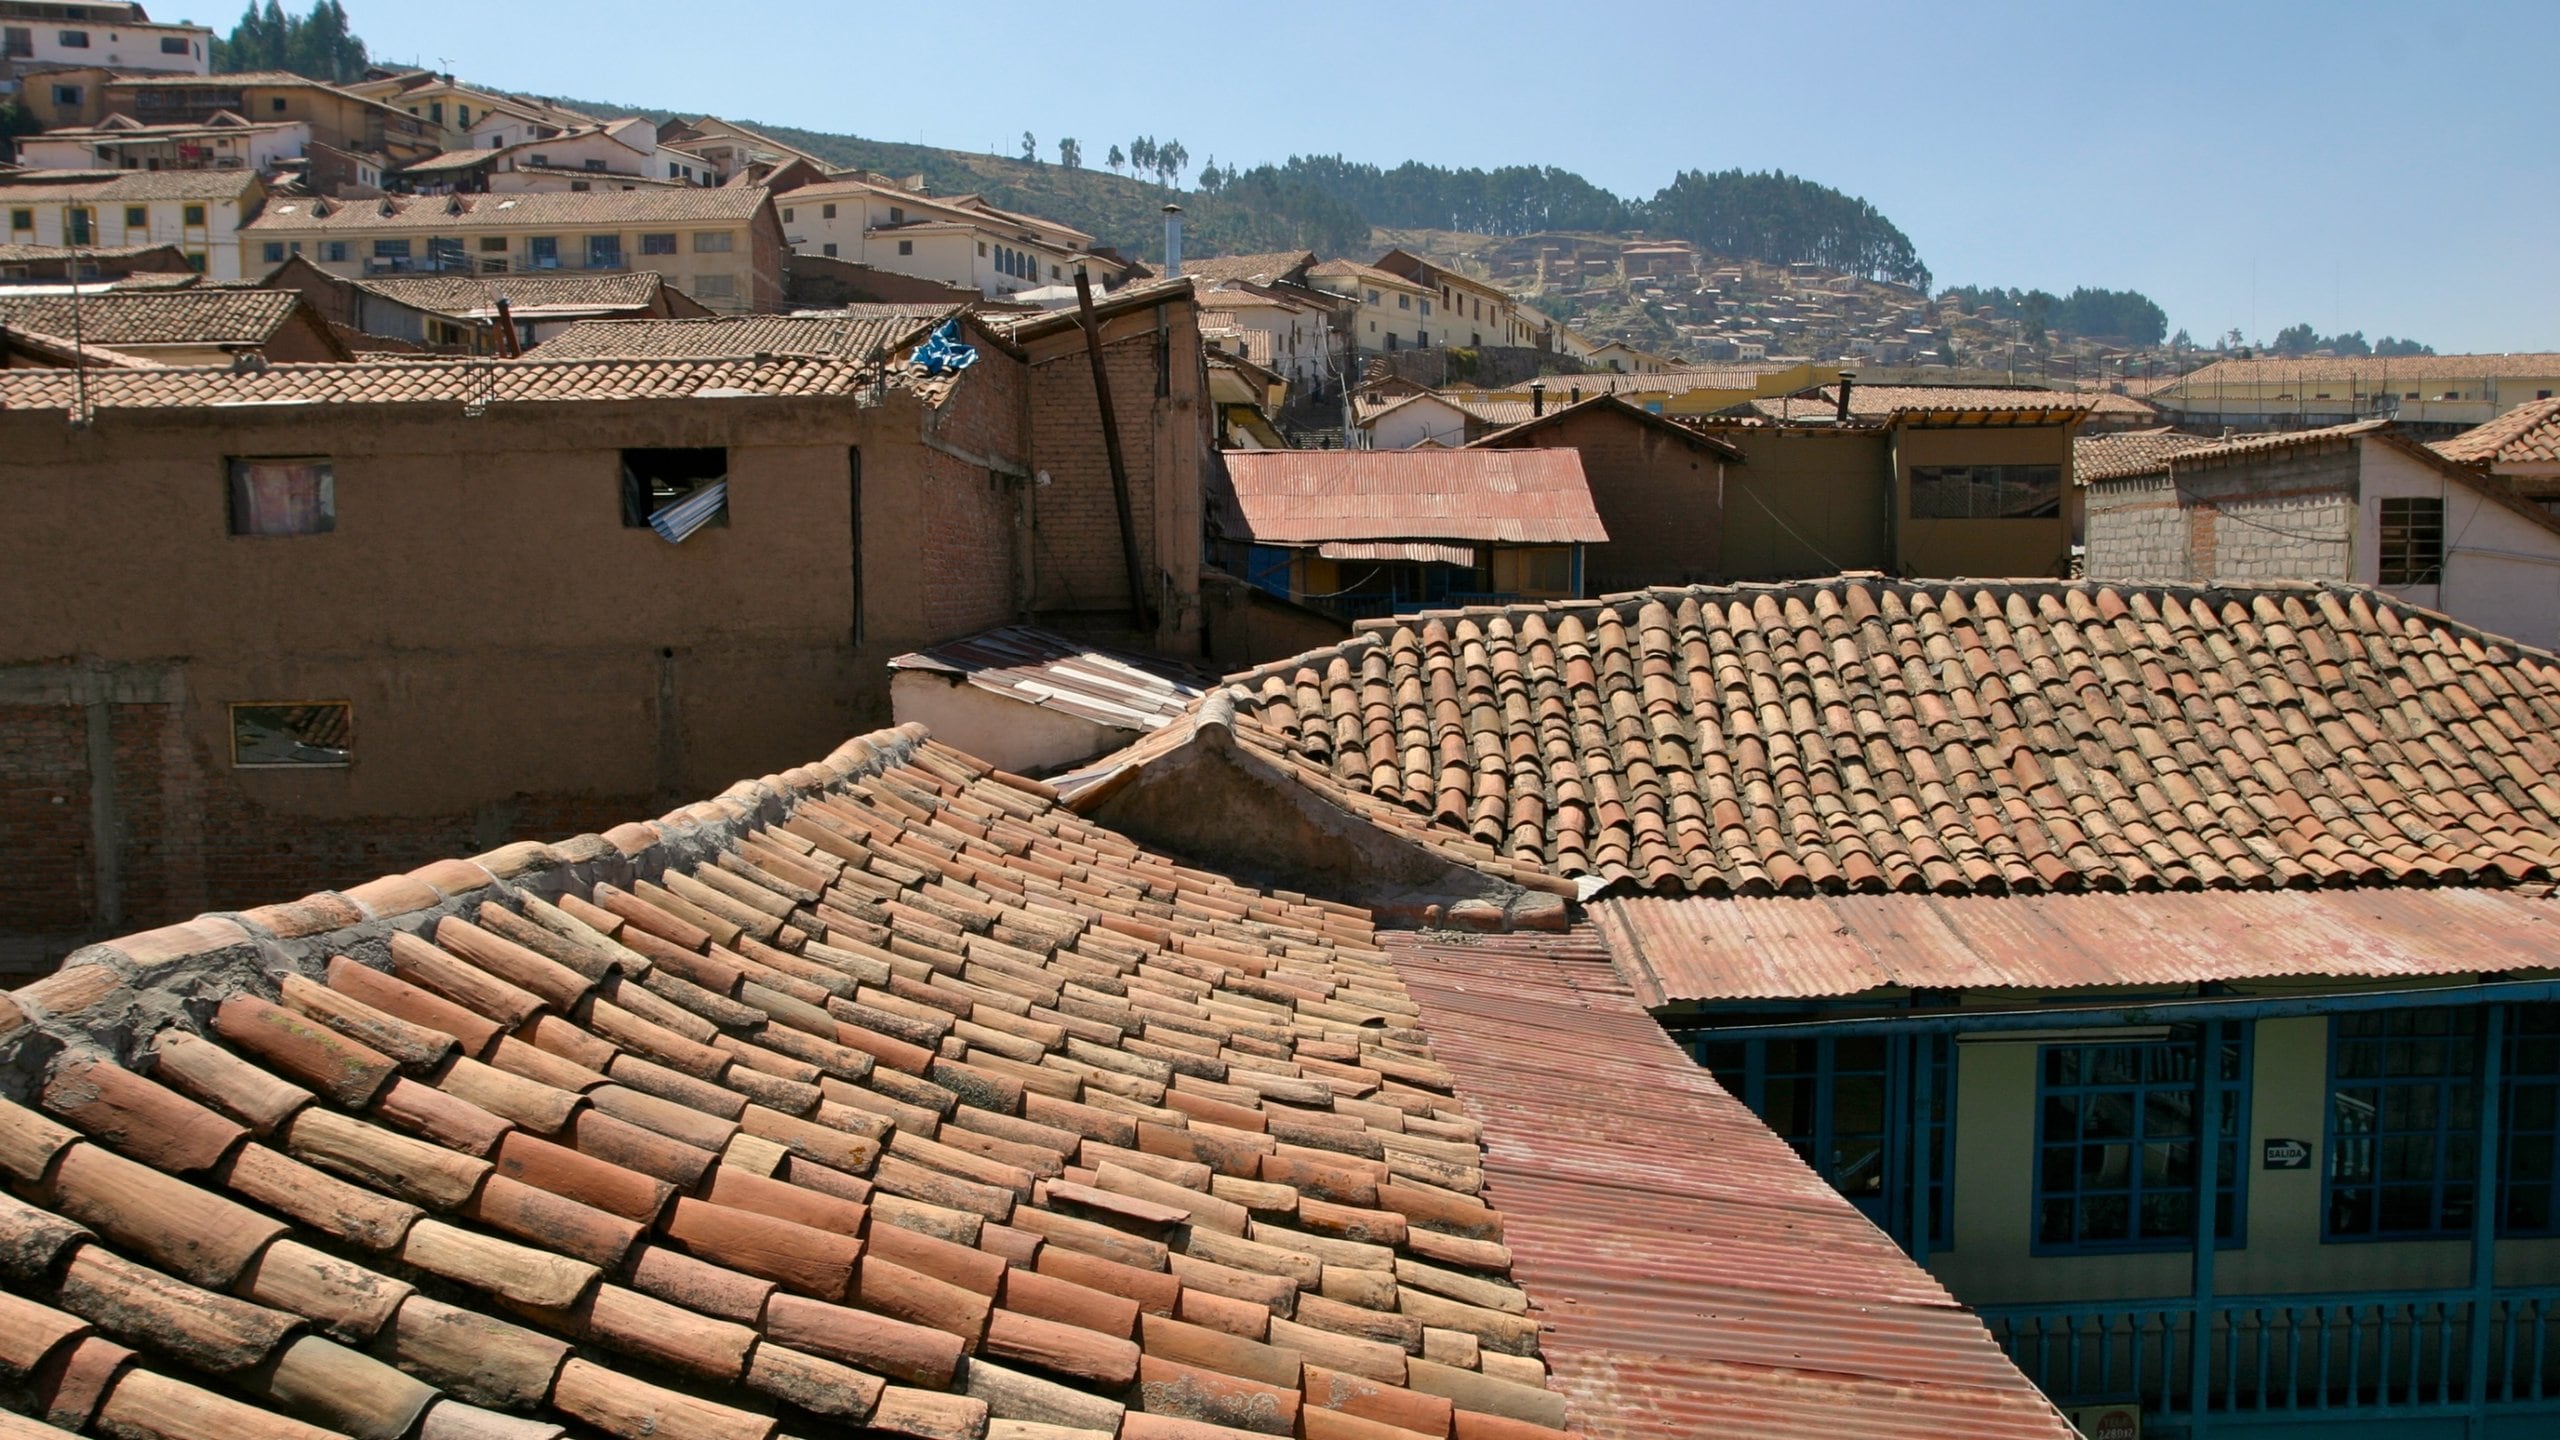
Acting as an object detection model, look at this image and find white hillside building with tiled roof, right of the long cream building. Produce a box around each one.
[776,177,1116,297]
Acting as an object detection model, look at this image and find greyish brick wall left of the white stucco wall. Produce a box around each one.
[2086,446,2355,582]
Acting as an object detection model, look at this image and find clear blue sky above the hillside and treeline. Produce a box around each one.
[345,0,2560,351]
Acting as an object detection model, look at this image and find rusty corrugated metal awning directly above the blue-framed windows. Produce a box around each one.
[1592,889,2560,1004]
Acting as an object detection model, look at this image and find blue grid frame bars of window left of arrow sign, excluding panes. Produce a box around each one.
[2028,1020,2258,1258]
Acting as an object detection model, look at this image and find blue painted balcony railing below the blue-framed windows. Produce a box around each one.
[1979,1286,2560,1420]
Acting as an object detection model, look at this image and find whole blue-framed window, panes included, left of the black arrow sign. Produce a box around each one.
[2033,1025,2250,1256]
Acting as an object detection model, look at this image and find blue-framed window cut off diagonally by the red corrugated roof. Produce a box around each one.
[1692,1035,1956,1250]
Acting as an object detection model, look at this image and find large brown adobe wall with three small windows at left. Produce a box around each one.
[0,379,1019,969]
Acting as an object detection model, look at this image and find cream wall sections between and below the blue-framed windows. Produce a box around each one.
[1928,1017,2560,1304]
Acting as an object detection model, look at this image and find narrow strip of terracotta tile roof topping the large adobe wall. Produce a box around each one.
[0,356,909,410]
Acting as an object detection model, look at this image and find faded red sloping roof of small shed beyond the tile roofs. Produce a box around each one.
[1226,451,1608,546]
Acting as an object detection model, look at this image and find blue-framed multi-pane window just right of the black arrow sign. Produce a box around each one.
[2322,1007,2481,1240]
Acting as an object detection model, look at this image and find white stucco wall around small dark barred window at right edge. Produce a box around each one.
[2355,443,2560,648]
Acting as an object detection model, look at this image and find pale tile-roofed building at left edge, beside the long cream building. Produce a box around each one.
[0,169,266,279]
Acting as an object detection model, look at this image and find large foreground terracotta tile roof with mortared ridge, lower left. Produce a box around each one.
[0,730,1597,1440]
